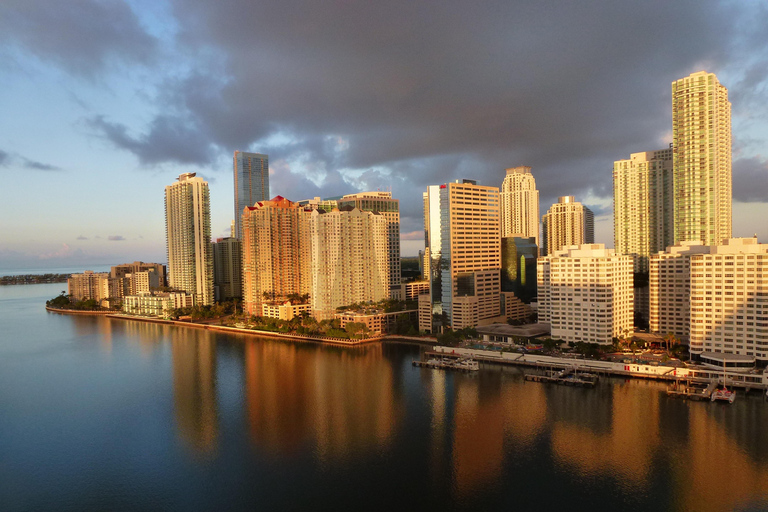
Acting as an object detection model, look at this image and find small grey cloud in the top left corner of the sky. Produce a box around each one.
[0,0,157,76]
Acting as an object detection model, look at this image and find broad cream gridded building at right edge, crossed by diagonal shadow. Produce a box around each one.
[651,238,768,363]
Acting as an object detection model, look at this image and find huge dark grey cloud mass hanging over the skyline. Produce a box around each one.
[82,0,768,232]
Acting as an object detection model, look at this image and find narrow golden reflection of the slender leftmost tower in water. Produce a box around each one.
[168,328,214,455]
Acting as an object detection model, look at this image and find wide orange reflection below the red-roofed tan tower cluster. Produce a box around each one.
[245,340,402,462]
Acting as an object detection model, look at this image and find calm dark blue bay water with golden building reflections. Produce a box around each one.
[0,284,768,511]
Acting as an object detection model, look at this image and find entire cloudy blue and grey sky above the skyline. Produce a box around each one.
[0,0,768,273]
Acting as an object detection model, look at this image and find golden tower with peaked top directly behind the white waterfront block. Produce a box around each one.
[541,196,595,254]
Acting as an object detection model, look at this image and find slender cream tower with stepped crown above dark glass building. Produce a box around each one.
[500,166,539,247]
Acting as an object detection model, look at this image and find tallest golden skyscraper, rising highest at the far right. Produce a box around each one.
[672,71,732,245]
